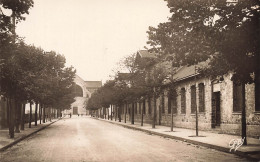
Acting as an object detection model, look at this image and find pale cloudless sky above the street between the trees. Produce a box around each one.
[16,0,170,83]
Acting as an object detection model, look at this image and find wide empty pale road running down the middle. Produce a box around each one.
[0,117,246,162]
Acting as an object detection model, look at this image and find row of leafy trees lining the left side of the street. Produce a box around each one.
[0,0,75,138]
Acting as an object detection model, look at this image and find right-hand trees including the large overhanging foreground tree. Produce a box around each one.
[88,0,260,144]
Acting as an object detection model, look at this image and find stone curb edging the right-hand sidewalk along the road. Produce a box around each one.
[96,118,259,161]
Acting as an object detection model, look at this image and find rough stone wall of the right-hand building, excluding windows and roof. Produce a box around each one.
[118,74,260,137]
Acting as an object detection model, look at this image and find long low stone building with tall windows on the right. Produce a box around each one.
[106,51,260,138]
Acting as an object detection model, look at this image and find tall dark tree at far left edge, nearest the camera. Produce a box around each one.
[0,0,33,138]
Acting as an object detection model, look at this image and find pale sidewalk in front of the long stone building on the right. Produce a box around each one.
[99,118,260,160]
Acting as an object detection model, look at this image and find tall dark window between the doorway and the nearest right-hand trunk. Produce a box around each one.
[233,83,243,112]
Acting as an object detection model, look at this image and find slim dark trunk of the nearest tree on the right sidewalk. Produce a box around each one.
[241,84,247,145]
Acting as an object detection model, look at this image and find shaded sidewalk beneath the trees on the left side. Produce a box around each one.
[0,119,59,152]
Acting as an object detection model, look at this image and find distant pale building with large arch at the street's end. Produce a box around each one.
[64,75,102,115]
